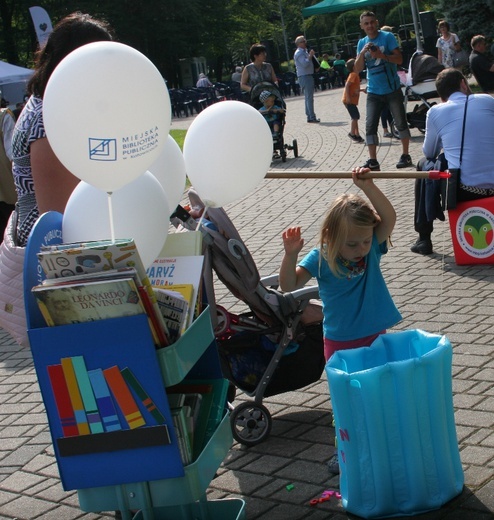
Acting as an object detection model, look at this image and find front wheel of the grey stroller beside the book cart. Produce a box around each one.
[230,402,272,446]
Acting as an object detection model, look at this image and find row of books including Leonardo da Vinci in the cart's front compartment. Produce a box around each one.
[32,239,171,347]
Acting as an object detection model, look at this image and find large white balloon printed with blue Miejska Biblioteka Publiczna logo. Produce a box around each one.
[43,42,171,191]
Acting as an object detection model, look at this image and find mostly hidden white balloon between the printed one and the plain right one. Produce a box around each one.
[148,135,186,213]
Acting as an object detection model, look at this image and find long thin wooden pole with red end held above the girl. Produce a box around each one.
[265,170,450,179]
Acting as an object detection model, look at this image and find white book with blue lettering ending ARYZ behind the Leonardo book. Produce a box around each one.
[147,255,204,327]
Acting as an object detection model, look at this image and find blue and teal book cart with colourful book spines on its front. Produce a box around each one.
[24,212,245,520]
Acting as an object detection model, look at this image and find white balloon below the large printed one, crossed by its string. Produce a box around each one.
[62,172,170,268]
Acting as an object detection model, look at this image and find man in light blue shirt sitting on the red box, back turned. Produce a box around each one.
[411,68,494,255]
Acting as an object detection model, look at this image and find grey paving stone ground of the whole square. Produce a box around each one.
[0,89,494,520]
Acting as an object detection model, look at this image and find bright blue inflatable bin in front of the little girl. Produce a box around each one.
[326,330,463,518]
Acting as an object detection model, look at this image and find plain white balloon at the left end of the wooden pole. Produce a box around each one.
[184,101,273,207]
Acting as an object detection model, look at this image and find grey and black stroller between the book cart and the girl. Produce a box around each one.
[172,189,325,446]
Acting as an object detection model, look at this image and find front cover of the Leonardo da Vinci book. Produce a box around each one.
[32,278,146,326]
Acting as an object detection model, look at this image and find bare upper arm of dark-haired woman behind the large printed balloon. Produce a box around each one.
[31,137,79,215]
